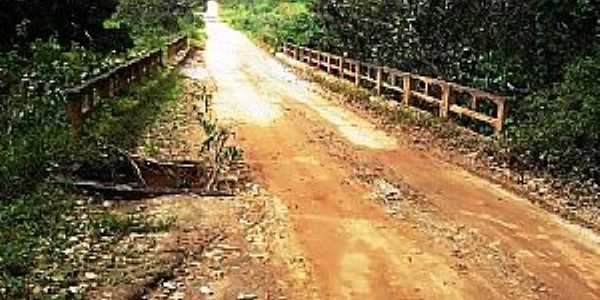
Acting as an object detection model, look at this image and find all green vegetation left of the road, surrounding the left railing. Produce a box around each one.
[0,0,204,299]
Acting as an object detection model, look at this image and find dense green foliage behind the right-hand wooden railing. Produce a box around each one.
[223,0,600,180]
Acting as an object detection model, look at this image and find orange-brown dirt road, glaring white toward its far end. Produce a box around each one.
[205,13,600,299]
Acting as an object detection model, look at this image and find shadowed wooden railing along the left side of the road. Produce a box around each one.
[67,36,188,138]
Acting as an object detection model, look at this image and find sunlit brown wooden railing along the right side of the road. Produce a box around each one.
[283,43,507,134]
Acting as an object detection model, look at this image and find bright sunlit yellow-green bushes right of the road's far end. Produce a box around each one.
[222,0,321,48]
